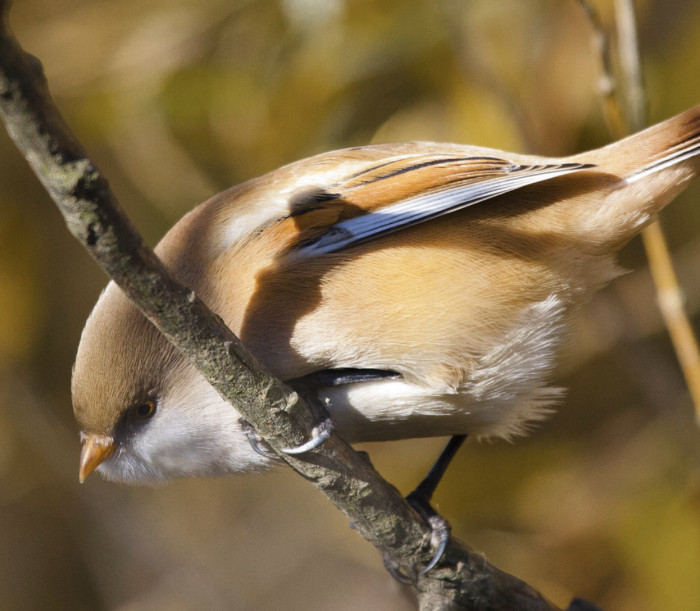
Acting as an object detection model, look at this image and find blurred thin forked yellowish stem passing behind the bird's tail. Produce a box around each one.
[578,0,700,424]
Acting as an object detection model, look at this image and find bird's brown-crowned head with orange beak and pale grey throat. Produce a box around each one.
[72,283,270,483]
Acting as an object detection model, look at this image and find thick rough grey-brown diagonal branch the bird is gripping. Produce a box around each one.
[0,0,593,610]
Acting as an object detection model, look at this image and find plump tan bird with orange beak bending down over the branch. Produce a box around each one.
[72,105,700,483]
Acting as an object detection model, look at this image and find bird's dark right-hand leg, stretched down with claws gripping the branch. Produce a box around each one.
[384,435,467,583]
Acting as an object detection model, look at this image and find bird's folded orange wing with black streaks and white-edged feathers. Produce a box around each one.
[290,155,593,256]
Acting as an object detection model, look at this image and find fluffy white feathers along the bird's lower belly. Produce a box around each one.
[322,295,565,442]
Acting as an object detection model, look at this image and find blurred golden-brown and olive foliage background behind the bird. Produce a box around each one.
[0,0,700,611]
